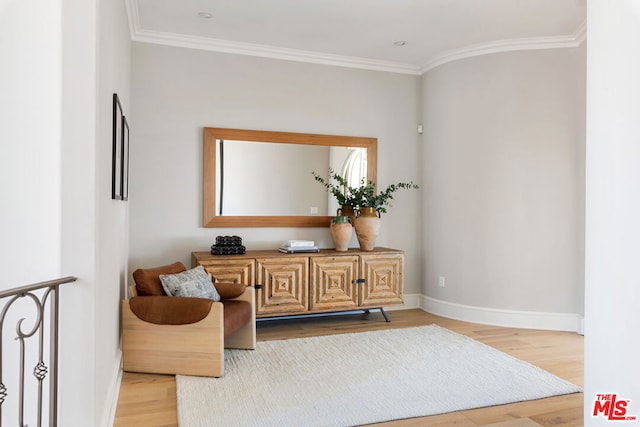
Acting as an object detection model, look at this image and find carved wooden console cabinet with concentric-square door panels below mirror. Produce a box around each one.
[191,248,404,317]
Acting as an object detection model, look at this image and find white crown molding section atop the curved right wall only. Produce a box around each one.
[420,20,587,74]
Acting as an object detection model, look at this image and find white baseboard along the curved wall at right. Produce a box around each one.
[420,295,584,334]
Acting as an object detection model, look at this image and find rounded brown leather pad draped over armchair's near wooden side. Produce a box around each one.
[129,296,213,325]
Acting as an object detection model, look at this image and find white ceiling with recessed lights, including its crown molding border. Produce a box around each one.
[127,0,586,74]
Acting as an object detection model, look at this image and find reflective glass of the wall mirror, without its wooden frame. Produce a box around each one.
[216,139,367,216]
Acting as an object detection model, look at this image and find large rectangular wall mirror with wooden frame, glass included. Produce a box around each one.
[203,128,378,227]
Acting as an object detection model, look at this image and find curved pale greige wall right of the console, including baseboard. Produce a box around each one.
[422,45,585,330]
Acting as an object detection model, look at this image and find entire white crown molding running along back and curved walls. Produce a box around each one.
[126,0,587,75]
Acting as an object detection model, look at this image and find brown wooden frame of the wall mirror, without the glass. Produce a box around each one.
[202,128,378,228]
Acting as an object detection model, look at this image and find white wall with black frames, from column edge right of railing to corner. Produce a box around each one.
[60,0,133,426]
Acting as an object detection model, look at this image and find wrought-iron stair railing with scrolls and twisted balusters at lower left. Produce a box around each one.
[0,276,76,427]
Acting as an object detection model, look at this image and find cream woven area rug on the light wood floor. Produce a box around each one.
[176,325,581,427]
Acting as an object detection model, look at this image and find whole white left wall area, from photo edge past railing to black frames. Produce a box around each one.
[0,0,130,426]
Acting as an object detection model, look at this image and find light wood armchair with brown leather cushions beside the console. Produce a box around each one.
[122,263,256,377]
